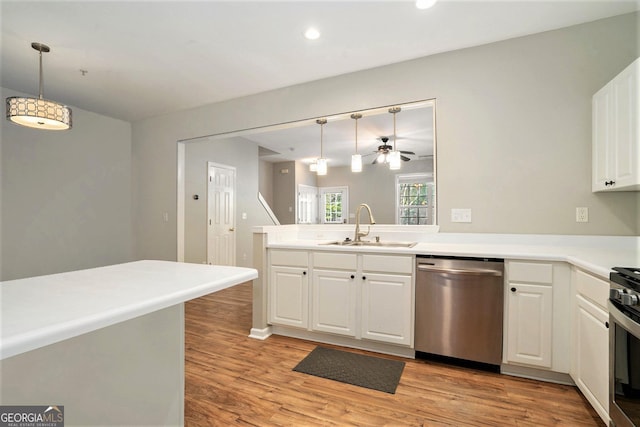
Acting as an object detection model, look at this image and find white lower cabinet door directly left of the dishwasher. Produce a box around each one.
[360,271,413,345]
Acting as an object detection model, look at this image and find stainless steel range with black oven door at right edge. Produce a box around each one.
[609,267,640,427]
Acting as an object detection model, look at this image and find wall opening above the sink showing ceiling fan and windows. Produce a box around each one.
[243,100,436,225]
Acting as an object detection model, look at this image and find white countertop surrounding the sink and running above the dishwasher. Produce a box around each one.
[254,225,640,280]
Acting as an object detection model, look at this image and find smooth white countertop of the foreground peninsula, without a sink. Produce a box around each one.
[0,261,258,359]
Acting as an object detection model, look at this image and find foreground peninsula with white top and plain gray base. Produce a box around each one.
[0,261,257,425]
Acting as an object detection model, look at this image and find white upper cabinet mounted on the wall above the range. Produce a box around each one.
[592,58,640,191]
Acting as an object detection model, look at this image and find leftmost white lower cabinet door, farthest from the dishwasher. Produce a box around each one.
[269,266,309,328]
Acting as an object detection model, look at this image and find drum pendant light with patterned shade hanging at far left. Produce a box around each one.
[7,42,71,130]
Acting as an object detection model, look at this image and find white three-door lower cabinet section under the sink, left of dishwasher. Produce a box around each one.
[268,250,415,347]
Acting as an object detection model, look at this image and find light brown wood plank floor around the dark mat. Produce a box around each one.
[185,283,604,426]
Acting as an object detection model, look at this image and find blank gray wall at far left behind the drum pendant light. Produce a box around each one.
[0,88,133,280]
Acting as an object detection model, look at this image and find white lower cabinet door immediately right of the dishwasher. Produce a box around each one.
[507,283,553,368]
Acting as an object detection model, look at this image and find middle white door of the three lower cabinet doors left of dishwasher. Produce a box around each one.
[311,270,356,336]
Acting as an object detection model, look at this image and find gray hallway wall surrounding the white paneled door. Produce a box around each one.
[182,137,269,267]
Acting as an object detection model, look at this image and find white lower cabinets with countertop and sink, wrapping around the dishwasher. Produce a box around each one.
[251,224,640,422]
